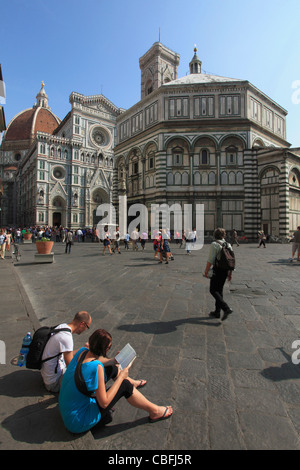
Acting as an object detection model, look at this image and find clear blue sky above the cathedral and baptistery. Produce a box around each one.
[0,0,300,147]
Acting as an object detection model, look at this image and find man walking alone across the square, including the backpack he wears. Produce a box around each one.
[204,228,235,321]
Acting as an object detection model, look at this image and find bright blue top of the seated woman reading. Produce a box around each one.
[58,348,105,433]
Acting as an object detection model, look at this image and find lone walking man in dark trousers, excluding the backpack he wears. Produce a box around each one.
[204,228,233,321]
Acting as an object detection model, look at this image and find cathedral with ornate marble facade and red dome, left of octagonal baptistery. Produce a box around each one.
[1,84,120,228]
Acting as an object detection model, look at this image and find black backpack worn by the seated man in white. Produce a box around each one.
[26,325,72,372]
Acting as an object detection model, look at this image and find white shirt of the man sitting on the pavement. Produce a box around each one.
[41,323,74,385]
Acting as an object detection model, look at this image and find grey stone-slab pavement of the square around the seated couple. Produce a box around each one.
[0,243,300,451]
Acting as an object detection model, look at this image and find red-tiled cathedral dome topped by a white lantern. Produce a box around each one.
[3,83,60,150]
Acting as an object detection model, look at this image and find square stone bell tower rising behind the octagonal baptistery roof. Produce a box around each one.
[139,42,180,99]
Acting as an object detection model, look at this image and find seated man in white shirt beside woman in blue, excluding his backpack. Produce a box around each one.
[41,311,92,393]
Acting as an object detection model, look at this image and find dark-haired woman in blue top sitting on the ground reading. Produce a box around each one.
[59,329,173,433]
